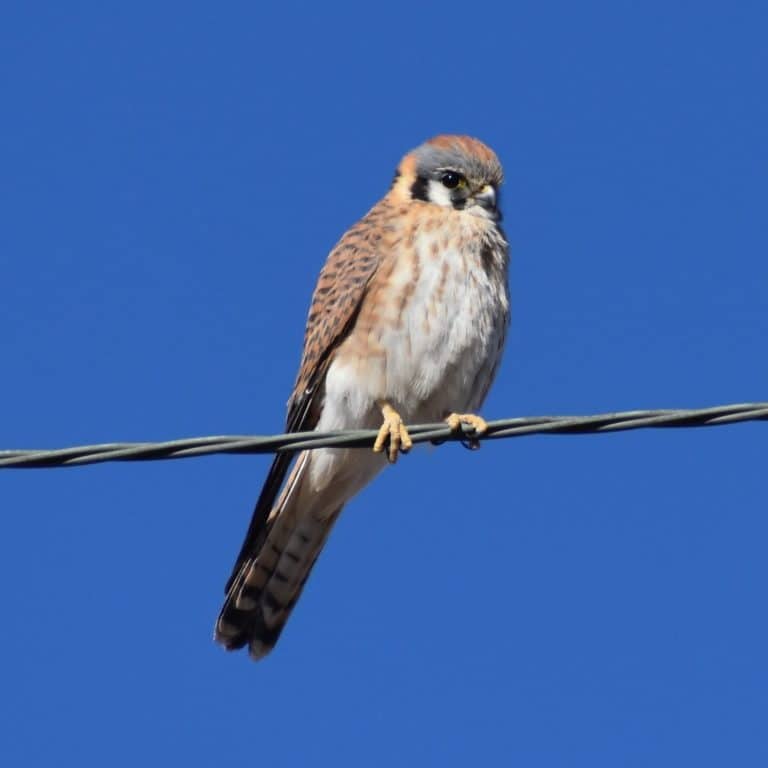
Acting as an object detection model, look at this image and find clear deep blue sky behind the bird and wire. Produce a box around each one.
[0,0,768,768]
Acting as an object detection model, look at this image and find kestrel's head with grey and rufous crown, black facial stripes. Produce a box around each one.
[392,135,504,221]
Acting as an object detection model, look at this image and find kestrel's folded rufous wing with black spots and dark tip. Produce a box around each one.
[225,206,383,592]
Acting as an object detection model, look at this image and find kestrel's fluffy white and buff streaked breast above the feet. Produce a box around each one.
[326,216,509,422]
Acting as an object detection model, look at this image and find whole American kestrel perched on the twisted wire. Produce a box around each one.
[215,136,509,659]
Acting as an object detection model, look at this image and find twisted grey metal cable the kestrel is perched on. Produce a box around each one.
[0,402,768,469]
